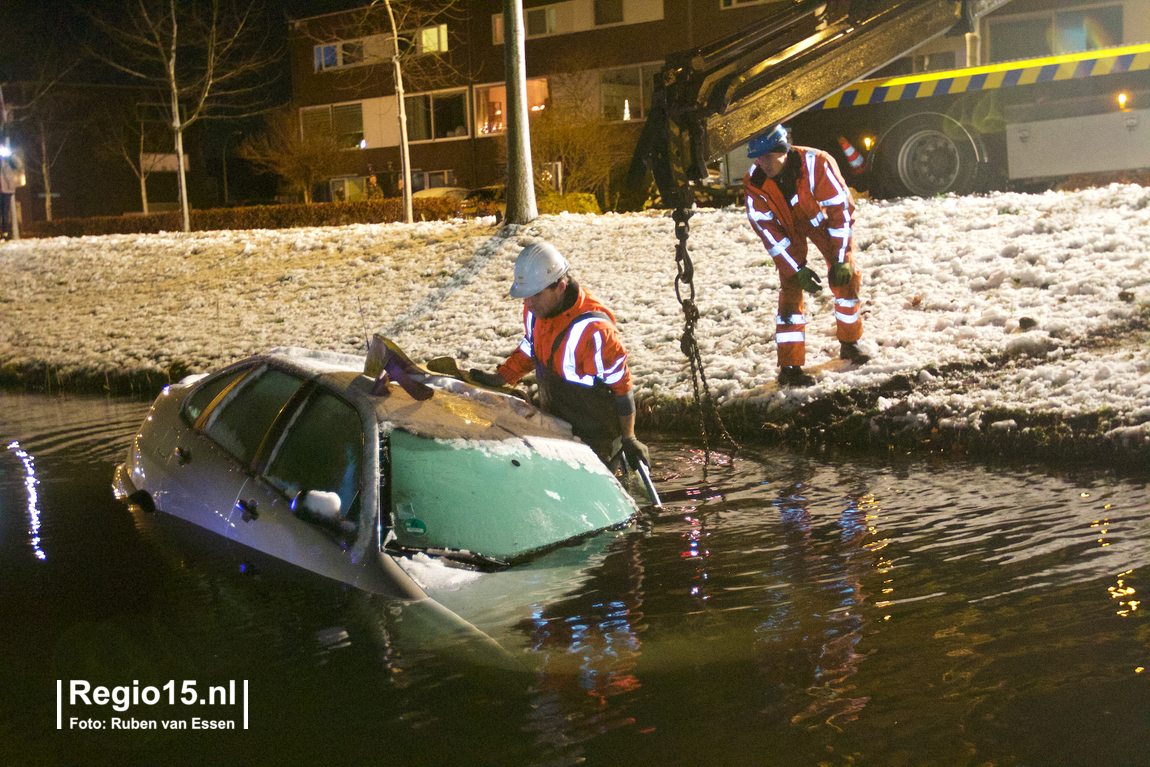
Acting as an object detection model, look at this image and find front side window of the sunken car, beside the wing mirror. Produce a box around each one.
[266,390,363,521]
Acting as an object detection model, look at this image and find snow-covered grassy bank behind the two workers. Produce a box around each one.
[0,184,1150,443]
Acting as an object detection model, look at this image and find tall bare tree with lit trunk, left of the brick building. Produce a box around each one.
[90,0,275,231]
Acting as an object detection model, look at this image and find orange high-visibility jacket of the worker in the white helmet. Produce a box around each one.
[498,286,631,396]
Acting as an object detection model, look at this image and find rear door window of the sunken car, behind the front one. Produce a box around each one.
[204,368,304,465]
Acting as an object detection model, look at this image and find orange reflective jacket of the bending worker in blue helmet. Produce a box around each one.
[743,146,854,277]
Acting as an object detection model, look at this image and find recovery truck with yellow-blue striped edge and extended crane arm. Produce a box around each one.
[633,0,1150,201]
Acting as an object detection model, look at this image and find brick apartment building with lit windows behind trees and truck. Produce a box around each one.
[290,0,1150,200]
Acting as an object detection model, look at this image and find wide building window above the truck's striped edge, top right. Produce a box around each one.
[989,6,1122,63]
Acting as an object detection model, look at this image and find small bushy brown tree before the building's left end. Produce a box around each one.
[239,106,343,204]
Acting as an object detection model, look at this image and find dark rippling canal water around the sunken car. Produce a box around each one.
[0,393,1150,767]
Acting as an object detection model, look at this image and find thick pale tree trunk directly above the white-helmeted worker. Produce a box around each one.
[504,0,538,224]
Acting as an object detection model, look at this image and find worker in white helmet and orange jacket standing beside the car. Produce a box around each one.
[469,241,651,468]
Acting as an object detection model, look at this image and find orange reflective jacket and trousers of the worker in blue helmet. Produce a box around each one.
[743,146,863,367]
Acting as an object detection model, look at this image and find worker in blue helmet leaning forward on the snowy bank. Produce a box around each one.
[743,125,871,386]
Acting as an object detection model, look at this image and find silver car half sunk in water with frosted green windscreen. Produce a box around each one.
[113,343,638,599]
